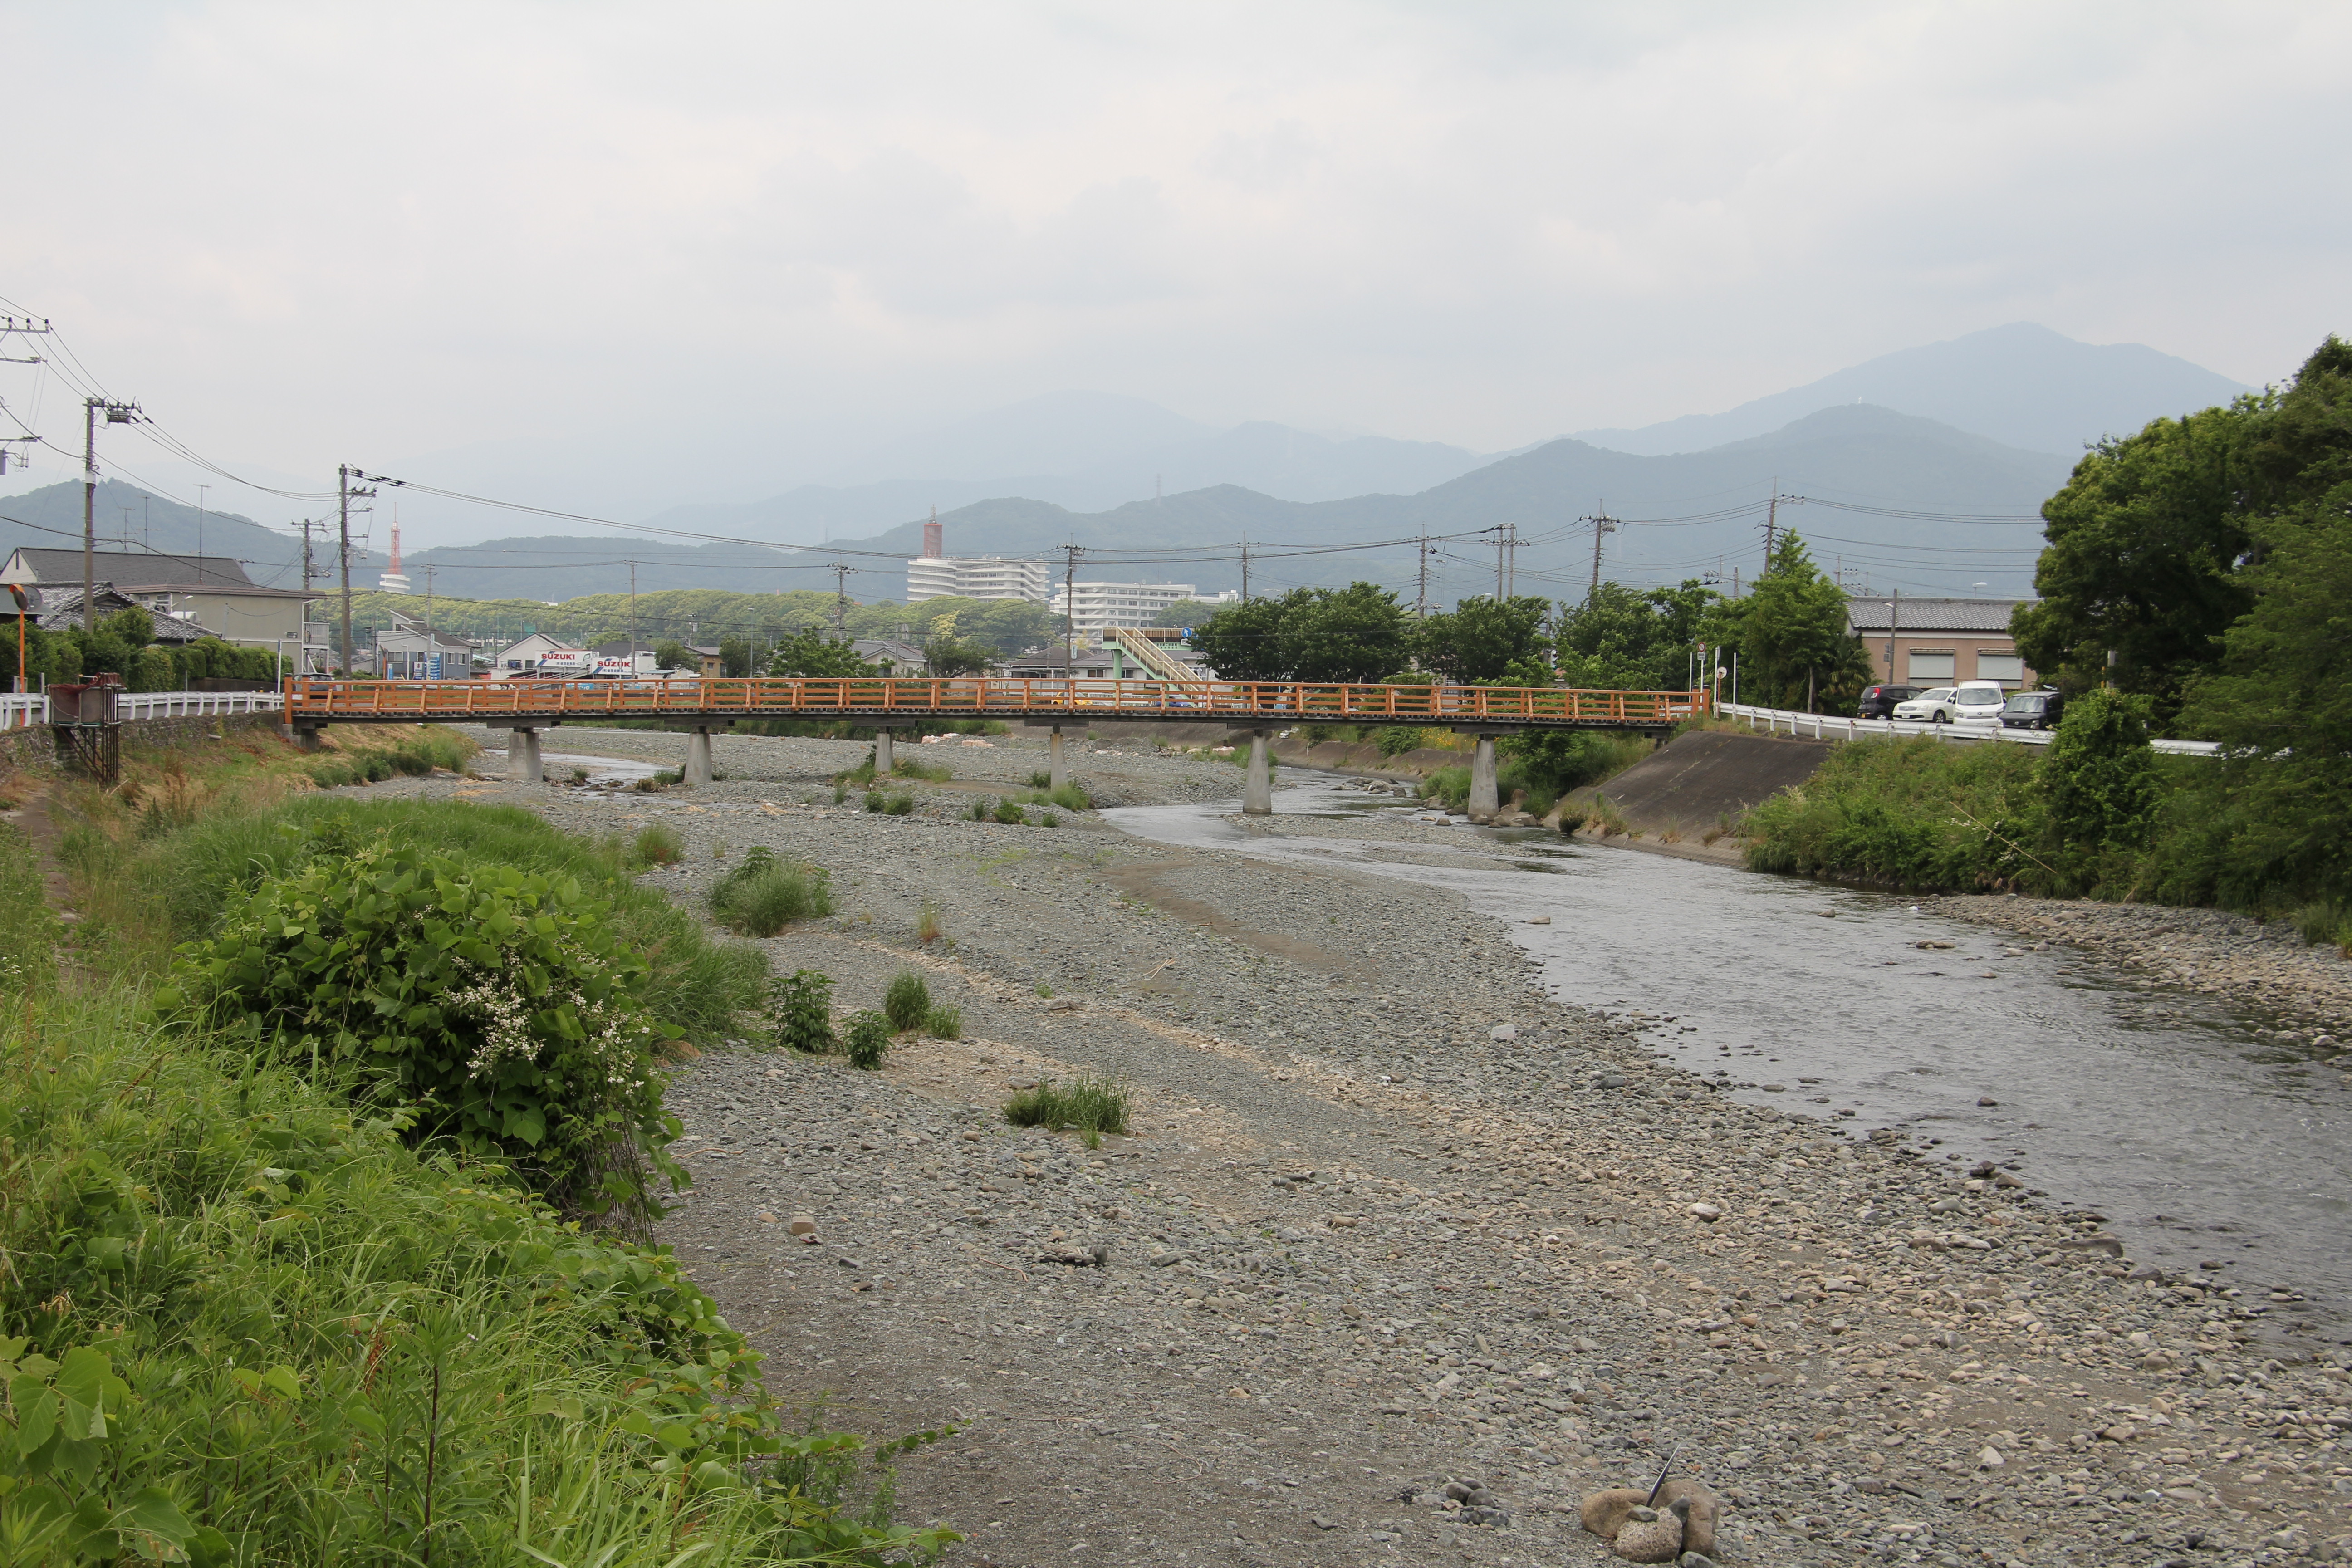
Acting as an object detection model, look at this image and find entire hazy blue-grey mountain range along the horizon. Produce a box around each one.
[0,322,2244,602]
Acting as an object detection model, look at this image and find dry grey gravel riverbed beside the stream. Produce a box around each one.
[343,729,2352,1566]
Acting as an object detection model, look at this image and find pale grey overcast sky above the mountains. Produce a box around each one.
[0,0,2352,540]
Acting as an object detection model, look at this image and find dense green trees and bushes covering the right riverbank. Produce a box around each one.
[1748,338,2352,943]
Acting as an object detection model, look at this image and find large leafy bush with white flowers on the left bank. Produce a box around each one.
[157,844,682,1213]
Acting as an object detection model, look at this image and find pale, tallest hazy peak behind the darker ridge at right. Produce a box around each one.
[1576,322,2249,458]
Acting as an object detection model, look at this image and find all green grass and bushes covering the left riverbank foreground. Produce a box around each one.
[0,769,948,1568]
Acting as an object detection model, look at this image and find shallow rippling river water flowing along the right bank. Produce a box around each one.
[1103,783,2352,1338]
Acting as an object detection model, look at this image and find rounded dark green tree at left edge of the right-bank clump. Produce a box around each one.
[2009,392,2272,724]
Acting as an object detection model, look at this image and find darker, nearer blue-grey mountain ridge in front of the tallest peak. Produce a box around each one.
[835,407,2070,602]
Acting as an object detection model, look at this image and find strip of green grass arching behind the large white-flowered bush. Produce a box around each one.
[137,794,767,1041]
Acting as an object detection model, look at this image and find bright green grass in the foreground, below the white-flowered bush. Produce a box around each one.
[0,832,955,1568]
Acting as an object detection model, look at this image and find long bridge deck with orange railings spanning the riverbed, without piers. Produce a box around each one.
[284,677,1708,731]
